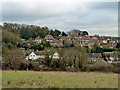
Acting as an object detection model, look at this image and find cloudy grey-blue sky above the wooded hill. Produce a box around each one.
[0,0,118,36]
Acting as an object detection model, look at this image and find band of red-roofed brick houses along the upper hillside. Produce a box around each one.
[39,34,117,48]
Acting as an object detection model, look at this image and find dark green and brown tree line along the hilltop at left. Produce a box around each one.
[3,23,67,40]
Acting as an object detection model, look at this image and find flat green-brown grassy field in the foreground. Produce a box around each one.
[2,71,118,88]
